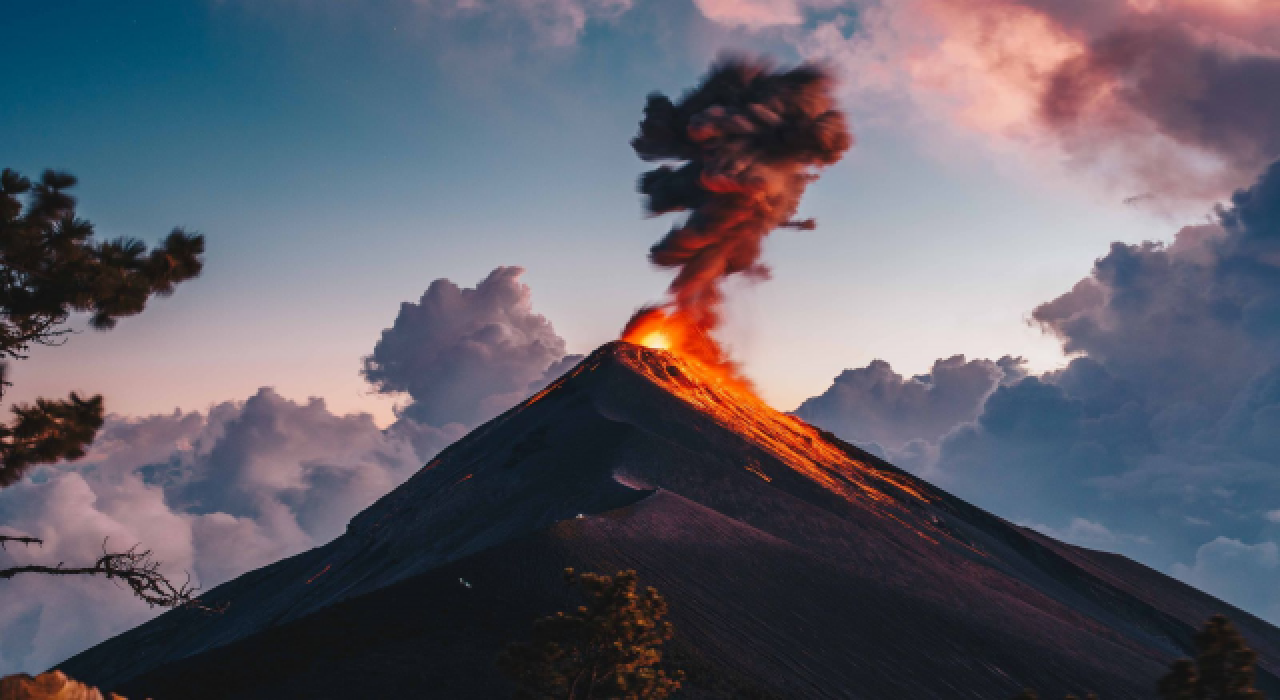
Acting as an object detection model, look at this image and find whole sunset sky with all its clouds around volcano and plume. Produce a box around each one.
[0,0,1280,672]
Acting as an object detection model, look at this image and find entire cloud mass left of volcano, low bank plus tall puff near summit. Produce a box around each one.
[0,267,580,676]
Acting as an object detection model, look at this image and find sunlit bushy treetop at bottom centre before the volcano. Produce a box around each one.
[498,568,682,700]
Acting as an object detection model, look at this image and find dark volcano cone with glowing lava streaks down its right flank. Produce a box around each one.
[60,343,1280,700]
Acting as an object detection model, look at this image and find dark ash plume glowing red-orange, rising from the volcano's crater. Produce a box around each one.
[622,55,854,375]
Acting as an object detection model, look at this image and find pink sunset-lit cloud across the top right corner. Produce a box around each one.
[698,0,1280,200]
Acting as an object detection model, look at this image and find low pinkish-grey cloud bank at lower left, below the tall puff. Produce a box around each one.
[0,389,422,673]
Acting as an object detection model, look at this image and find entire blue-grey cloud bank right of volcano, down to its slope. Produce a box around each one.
[805,163,1280,621]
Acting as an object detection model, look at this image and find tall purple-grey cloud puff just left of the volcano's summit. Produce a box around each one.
[364,267,576,426]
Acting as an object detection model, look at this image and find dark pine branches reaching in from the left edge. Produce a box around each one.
[0,169,205,607]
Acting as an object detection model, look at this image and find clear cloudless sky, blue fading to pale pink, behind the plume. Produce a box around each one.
[0,1,1172,421]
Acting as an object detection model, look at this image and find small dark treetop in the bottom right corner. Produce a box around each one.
[1160,616,1263,700]
